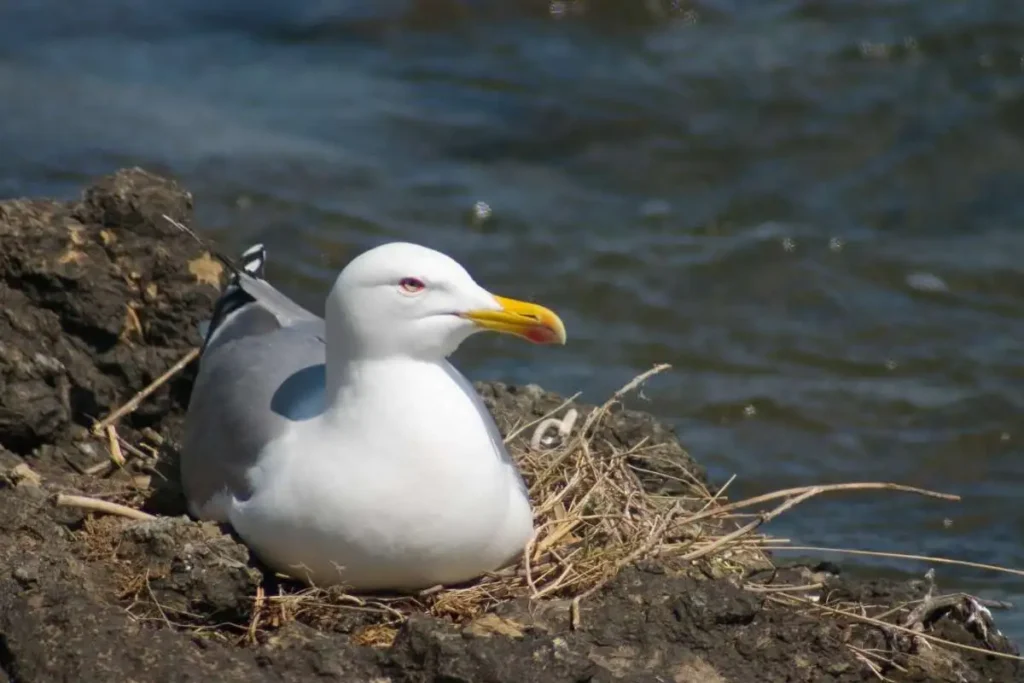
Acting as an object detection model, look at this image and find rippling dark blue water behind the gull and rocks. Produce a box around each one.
[0,0,1024,640]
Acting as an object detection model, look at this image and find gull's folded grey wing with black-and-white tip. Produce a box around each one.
[181,245,326,521]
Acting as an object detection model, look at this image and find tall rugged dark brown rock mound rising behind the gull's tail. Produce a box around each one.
[0,169,217,473]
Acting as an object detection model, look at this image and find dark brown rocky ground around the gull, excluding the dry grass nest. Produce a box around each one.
[0,170,1024,683]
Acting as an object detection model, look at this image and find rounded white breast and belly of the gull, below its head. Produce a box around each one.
[230,361,532,590]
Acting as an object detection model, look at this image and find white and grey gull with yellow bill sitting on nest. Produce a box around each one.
[180,242,566,593]
